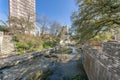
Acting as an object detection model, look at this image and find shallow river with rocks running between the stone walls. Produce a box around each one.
[0,47,88,80]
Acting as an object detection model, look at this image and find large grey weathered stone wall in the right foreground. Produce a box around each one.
[83,42,120,80]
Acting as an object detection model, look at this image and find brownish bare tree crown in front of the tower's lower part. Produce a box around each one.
[9,16,35,34]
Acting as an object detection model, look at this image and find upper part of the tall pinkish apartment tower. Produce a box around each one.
[9,0,36,22]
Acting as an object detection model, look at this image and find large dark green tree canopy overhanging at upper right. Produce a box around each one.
[71,0,120,42]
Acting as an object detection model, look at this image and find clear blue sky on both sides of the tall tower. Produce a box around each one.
[0,0,77,26]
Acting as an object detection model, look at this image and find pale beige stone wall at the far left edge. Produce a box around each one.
[0,35,16,58]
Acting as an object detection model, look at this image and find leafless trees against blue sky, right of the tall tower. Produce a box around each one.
[37,16,67,42]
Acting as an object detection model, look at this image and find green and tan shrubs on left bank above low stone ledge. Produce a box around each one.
[13,34,58,54]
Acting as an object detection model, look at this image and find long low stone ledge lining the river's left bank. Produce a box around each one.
[0,47,60,70]
